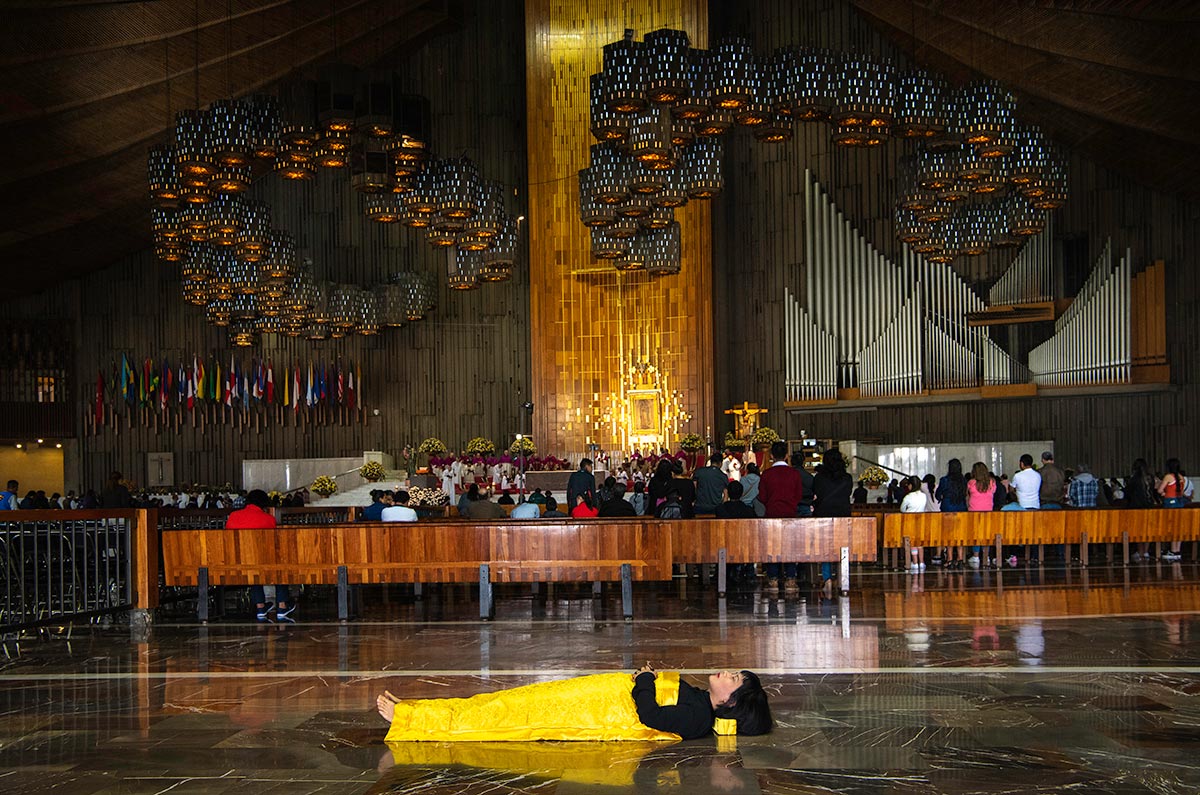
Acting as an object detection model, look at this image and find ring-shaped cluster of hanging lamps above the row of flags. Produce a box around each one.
[148,66,517,346]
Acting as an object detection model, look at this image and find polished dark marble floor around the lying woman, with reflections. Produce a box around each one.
[0,563,1200,795]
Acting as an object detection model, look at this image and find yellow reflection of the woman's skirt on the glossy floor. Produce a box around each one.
[389,741,662,787]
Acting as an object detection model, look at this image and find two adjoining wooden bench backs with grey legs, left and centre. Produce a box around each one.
[154,518,875,618]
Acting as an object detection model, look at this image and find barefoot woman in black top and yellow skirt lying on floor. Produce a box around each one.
[376,665,772,742]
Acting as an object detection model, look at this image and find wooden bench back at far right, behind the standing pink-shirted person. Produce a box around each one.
[883,508,1200,548]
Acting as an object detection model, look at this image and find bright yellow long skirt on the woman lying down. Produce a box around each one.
[385,674,679,743]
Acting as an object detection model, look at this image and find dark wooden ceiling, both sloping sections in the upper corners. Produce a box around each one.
[0,0,1200,293]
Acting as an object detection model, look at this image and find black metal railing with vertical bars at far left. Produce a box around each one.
[0,510,136,633]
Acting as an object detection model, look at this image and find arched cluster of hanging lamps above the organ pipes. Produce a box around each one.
[580,30,1067,273]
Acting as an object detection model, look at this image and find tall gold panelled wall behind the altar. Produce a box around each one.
[526,0,713,454]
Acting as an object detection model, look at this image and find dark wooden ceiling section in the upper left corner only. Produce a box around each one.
[0,0,452,299]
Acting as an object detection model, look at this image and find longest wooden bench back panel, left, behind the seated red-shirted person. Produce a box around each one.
[162,520,671,585]
